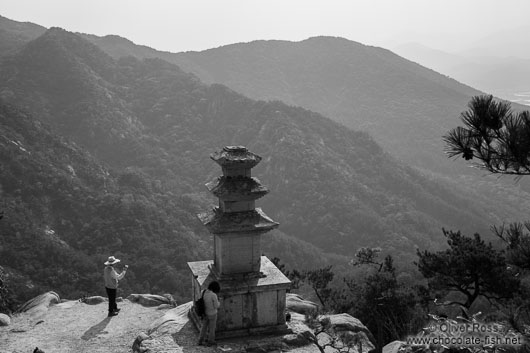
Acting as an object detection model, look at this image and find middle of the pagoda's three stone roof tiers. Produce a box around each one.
[206,176,269,201]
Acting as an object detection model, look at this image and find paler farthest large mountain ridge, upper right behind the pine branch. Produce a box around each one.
[79,37,479,174]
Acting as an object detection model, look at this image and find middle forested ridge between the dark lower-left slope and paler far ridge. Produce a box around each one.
[0,29,503,262]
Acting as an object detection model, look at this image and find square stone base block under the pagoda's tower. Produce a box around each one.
[188,256,291,339]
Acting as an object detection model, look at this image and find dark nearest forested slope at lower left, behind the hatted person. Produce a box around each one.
[0,102,210,299]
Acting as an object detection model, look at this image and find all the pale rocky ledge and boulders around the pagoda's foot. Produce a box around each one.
[0,292,373,353]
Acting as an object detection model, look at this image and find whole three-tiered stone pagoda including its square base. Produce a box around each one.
[188,146,291,338]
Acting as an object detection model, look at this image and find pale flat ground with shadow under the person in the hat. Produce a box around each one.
[0,300,166,353]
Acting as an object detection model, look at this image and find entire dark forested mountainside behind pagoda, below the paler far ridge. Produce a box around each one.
[0,28,526,306]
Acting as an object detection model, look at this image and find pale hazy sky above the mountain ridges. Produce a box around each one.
[0,0,530,52]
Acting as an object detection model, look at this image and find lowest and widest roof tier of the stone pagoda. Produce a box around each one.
[198,207,279,234]
